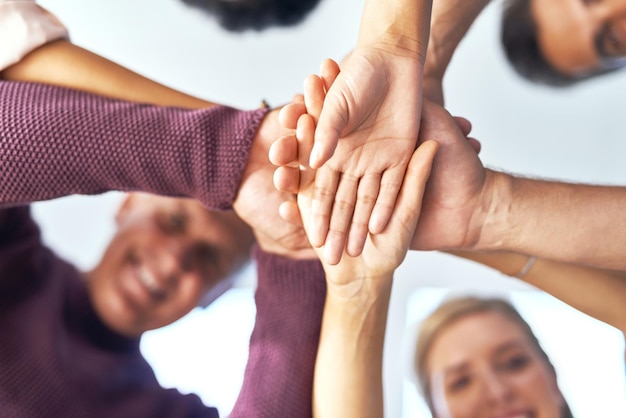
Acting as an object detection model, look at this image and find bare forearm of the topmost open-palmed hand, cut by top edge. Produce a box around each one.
[357,0,432,60]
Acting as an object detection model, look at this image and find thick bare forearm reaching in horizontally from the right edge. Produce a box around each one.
[475,172,626,270]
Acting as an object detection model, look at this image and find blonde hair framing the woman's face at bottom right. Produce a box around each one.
[414,296,572,418]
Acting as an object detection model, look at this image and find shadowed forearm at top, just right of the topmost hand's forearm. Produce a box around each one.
[424,0,490,80]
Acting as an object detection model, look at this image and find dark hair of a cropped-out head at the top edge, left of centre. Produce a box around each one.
[182,0,320,32]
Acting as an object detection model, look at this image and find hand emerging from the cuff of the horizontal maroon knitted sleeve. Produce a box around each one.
[233,110,315,258]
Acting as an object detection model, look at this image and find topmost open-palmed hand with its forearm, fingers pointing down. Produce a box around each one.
[275,0,431,264]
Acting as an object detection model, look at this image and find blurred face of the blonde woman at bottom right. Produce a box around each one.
[426,312,564,418]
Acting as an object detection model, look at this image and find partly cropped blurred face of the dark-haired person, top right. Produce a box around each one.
[531,0,626,76]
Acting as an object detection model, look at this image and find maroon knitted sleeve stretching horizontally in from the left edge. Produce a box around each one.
[0,81,267,209]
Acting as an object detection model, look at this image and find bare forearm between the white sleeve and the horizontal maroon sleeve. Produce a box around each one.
[0,40,214,109]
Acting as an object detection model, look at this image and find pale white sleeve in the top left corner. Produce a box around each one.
[0,0,69,71]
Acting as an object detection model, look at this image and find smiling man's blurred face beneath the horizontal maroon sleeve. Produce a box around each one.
[87,193,254,336]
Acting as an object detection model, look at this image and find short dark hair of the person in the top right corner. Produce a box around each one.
[500,0,618,87]
